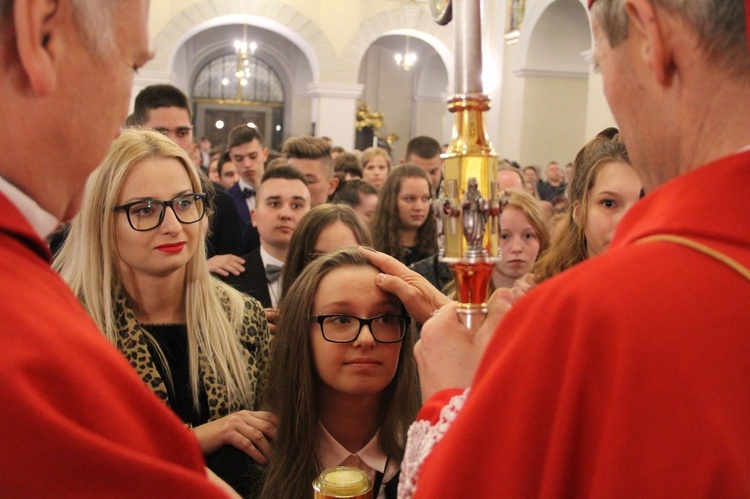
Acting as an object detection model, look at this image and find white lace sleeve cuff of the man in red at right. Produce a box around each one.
[398,388,470,499]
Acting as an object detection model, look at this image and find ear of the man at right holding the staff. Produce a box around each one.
[625,0,675,86]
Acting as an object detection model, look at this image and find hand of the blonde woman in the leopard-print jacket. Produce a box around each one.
[193,411,278,464]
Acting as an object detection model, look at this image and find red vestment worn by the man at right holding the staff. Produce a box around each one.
[416,152,750,498]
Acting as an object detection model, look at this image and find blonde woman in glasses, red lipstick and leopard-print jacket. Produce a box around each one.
[55,130,275,491]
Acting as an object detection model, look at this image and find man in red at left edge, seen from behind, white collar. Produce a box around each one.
[0,0,232,498]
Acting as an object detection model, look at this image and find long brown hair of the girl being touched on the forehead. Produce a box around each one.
[261,248,419,499]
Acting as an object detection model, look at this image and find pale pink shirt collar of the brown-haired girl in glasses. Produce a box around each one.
[316,423,401,483]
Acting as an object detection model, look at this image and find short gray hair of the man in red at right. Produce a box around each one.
[591,0,750,75]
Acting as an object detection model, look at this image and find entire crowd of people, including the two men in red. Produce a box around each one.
[0,0,750,499]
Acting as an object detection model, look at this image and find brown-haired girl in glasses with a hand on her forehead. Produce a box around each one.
[262,248,419,498]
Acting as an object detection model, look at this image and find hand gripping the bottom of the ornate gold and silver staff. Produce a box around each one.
[414,289,515,401]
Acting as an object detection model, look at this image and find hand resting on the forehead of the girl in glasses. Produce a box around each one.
[359,247,451,324]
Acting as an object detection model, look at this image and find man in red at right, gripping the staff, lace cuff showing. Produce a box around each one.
[377,0,750,498]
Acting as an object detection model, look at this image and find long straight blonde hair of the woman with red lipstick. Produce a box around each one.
[53,129,254,408]
